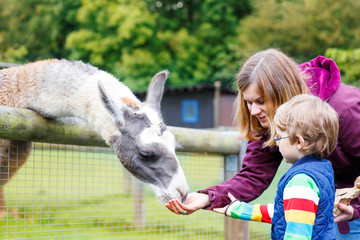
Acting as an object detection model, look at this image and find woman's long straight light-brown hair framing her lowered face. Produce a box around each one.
[235,49,309,146]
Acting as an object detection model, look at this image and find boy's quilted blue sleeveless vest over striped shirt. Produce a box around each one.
[271,155,336,240]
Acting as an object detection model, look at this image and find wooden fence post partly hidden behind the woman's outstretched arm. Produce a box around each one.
[224,140,250,240]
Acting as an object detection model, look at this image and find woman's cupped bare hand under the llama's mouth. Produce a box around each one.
[165,192,210,215]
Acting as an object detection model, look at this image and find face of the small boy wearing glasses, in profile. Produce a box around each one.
[276,129,302,164]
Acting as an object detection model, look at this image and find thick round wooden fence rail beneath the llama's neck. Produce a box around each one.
[0,106,240,155]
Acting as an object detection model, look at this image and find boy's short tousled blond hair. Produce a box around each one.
[272,94,339,158]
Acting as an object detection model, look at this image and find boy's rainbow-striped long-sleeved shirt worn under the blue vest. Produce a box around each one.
[226,173,320,239]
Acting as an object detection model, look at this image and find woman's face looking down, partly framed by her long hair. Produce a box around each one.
[243,84,269,128]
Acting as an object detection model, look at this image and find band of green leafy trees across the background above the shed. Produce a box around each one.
[7,0,360,90]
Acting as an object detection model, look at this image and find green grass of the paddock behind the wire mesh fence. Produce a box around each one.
[0,145,286,240]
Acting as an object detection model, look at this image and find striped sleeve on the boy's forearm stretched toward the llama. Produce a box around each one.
[225,200,274,223]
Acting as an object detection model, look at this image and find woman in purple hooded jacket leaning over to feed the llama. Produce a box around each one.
[166,49,360,239]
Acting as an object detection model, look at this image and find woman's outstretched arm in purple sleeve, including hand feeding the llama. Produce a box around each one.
[165,137,282,214]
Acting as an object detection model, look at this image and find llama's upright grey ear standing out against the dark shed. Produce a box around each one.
[146,70,169,113]
